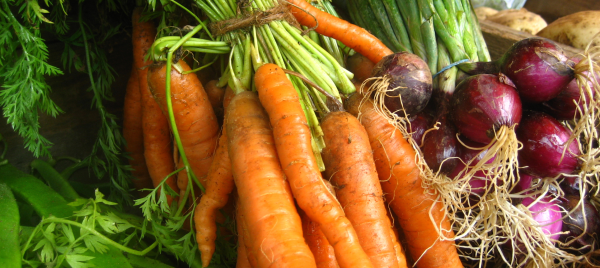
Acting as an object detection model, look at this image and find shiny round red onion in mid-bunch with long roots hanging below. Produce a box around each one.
[450,74,522,144]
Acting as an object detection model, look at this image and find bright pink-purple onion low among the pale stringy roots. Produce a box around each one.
[522,197,563,240]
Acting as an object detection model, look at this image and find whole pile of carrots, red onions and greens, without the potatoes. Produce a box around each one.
[0,0,600,268]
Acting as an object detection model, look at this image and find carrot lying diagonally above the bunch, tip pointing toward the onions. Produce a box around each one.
[287,0,393,63]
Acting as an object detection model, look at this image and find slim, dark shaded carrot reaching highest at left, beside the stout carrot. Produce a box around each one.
[131,7,179,204]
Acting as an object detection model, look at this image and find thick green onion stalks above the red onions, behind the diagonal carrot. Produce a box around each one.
[348,0,491,74]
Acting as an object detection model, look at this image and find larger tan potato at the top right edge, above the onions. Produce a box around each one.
[537,10,600,49]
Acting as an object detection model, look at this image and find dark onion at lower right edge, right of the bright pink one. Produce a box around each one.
[559,195,600,254]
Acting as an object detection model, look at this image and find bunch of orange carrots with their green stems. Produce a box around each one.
[123,0,462,267]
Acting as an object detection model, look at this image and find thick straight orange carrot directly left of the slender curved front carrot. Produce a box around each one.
[225,91,316,268]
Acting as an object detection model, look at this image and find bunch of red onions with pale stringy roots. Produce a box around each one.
[364,37,600,266]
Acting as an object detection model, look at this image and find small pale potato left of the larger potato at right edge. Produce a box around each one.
[487,8,548,34]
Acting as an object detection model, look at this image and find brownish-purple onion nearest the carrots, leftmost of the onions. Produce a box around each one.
[372,52,433,116]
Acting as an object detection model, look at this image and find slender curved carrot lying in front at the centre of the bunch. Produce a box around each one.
[254,63,372,267]
